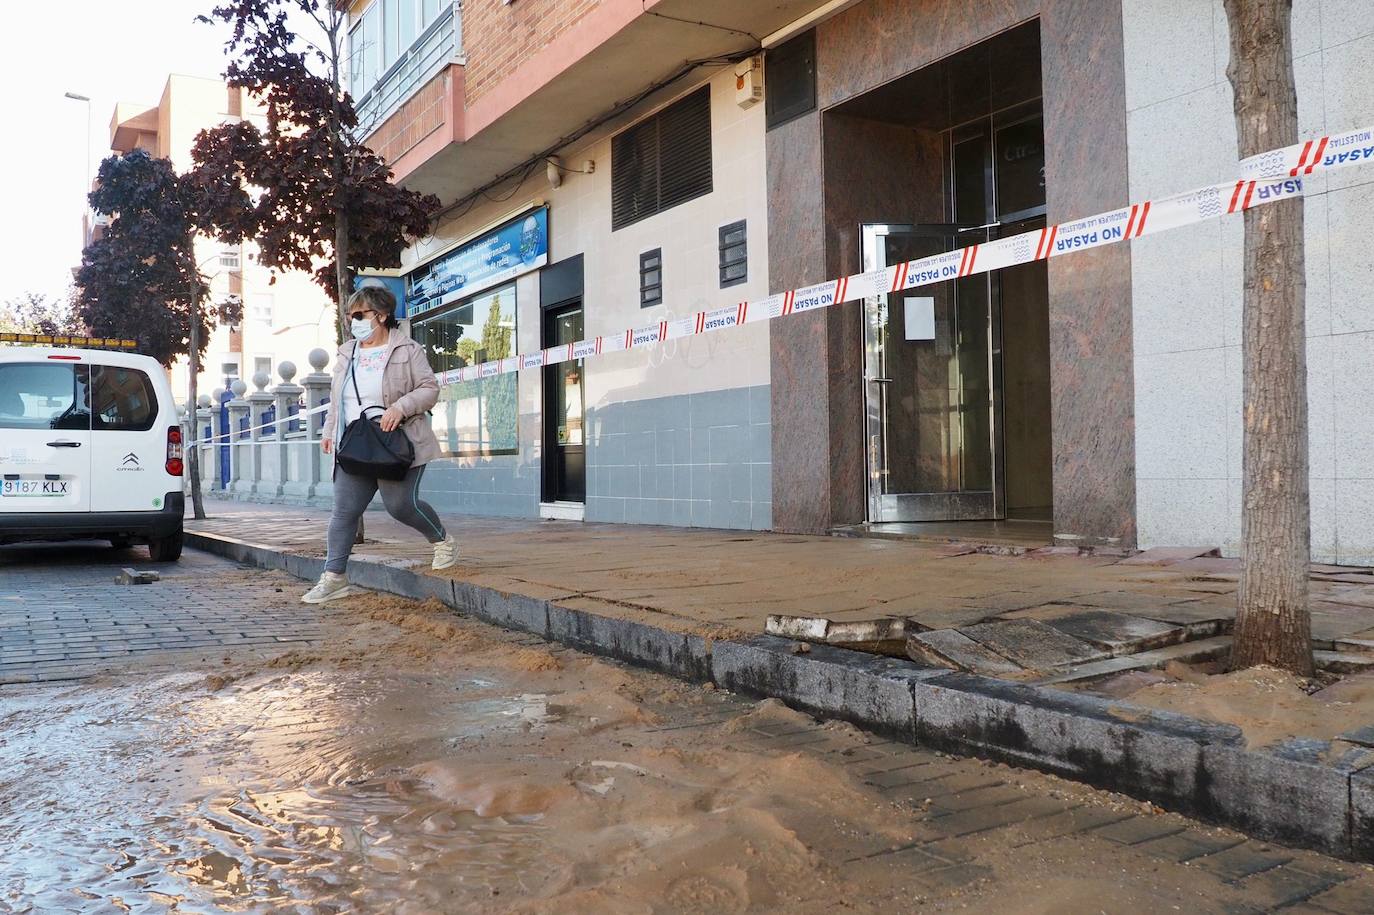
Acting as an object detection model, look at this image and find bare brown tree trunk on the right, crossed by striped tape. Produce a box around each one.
[1224,0,1312,676]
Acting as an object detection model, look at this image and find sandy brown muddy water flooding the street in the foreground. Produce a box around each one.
[0,603,928,912]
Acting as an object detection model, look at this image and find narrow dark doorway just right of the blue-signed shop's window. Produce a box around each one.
[543,300,587,505]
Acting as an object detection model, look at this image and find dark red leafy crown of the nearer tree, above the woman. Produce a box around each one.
[188,0,438,334]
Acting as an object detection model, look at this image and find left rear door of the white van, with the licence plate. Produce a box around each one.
[0,356,91,514]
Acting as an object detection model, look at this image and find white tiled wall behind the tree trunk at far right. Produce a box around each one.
[1123,0,1374,565]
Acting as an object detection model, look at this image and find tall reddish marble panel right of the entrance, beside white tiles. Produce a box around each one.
[1040,0,1136,545]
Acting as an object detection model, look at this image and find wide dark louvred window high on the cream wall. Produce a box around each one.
[610,87,712,231]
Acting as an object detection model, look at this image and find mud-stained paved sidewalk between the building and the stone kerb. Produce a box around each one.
[187,500,1374,657]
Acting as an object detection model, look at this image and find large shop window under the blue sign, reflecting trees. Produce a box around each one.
[411,284,518,458]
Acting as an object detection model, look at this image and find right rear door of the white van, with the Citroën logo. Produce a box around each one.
[91,363,173,511]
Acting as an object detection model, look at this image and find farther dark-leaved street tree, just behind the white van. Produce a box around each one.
[76,150,242,518]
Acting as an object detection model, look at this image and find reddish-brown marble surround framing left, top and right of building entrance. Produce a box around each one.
[767,0,1135,545]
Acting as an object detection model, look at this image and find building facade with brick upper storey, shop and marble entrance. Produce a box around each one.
[350,0,1374,563]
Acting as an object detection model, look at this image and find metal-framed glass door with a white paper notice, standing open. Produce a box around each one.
[863,224,1003,522]
